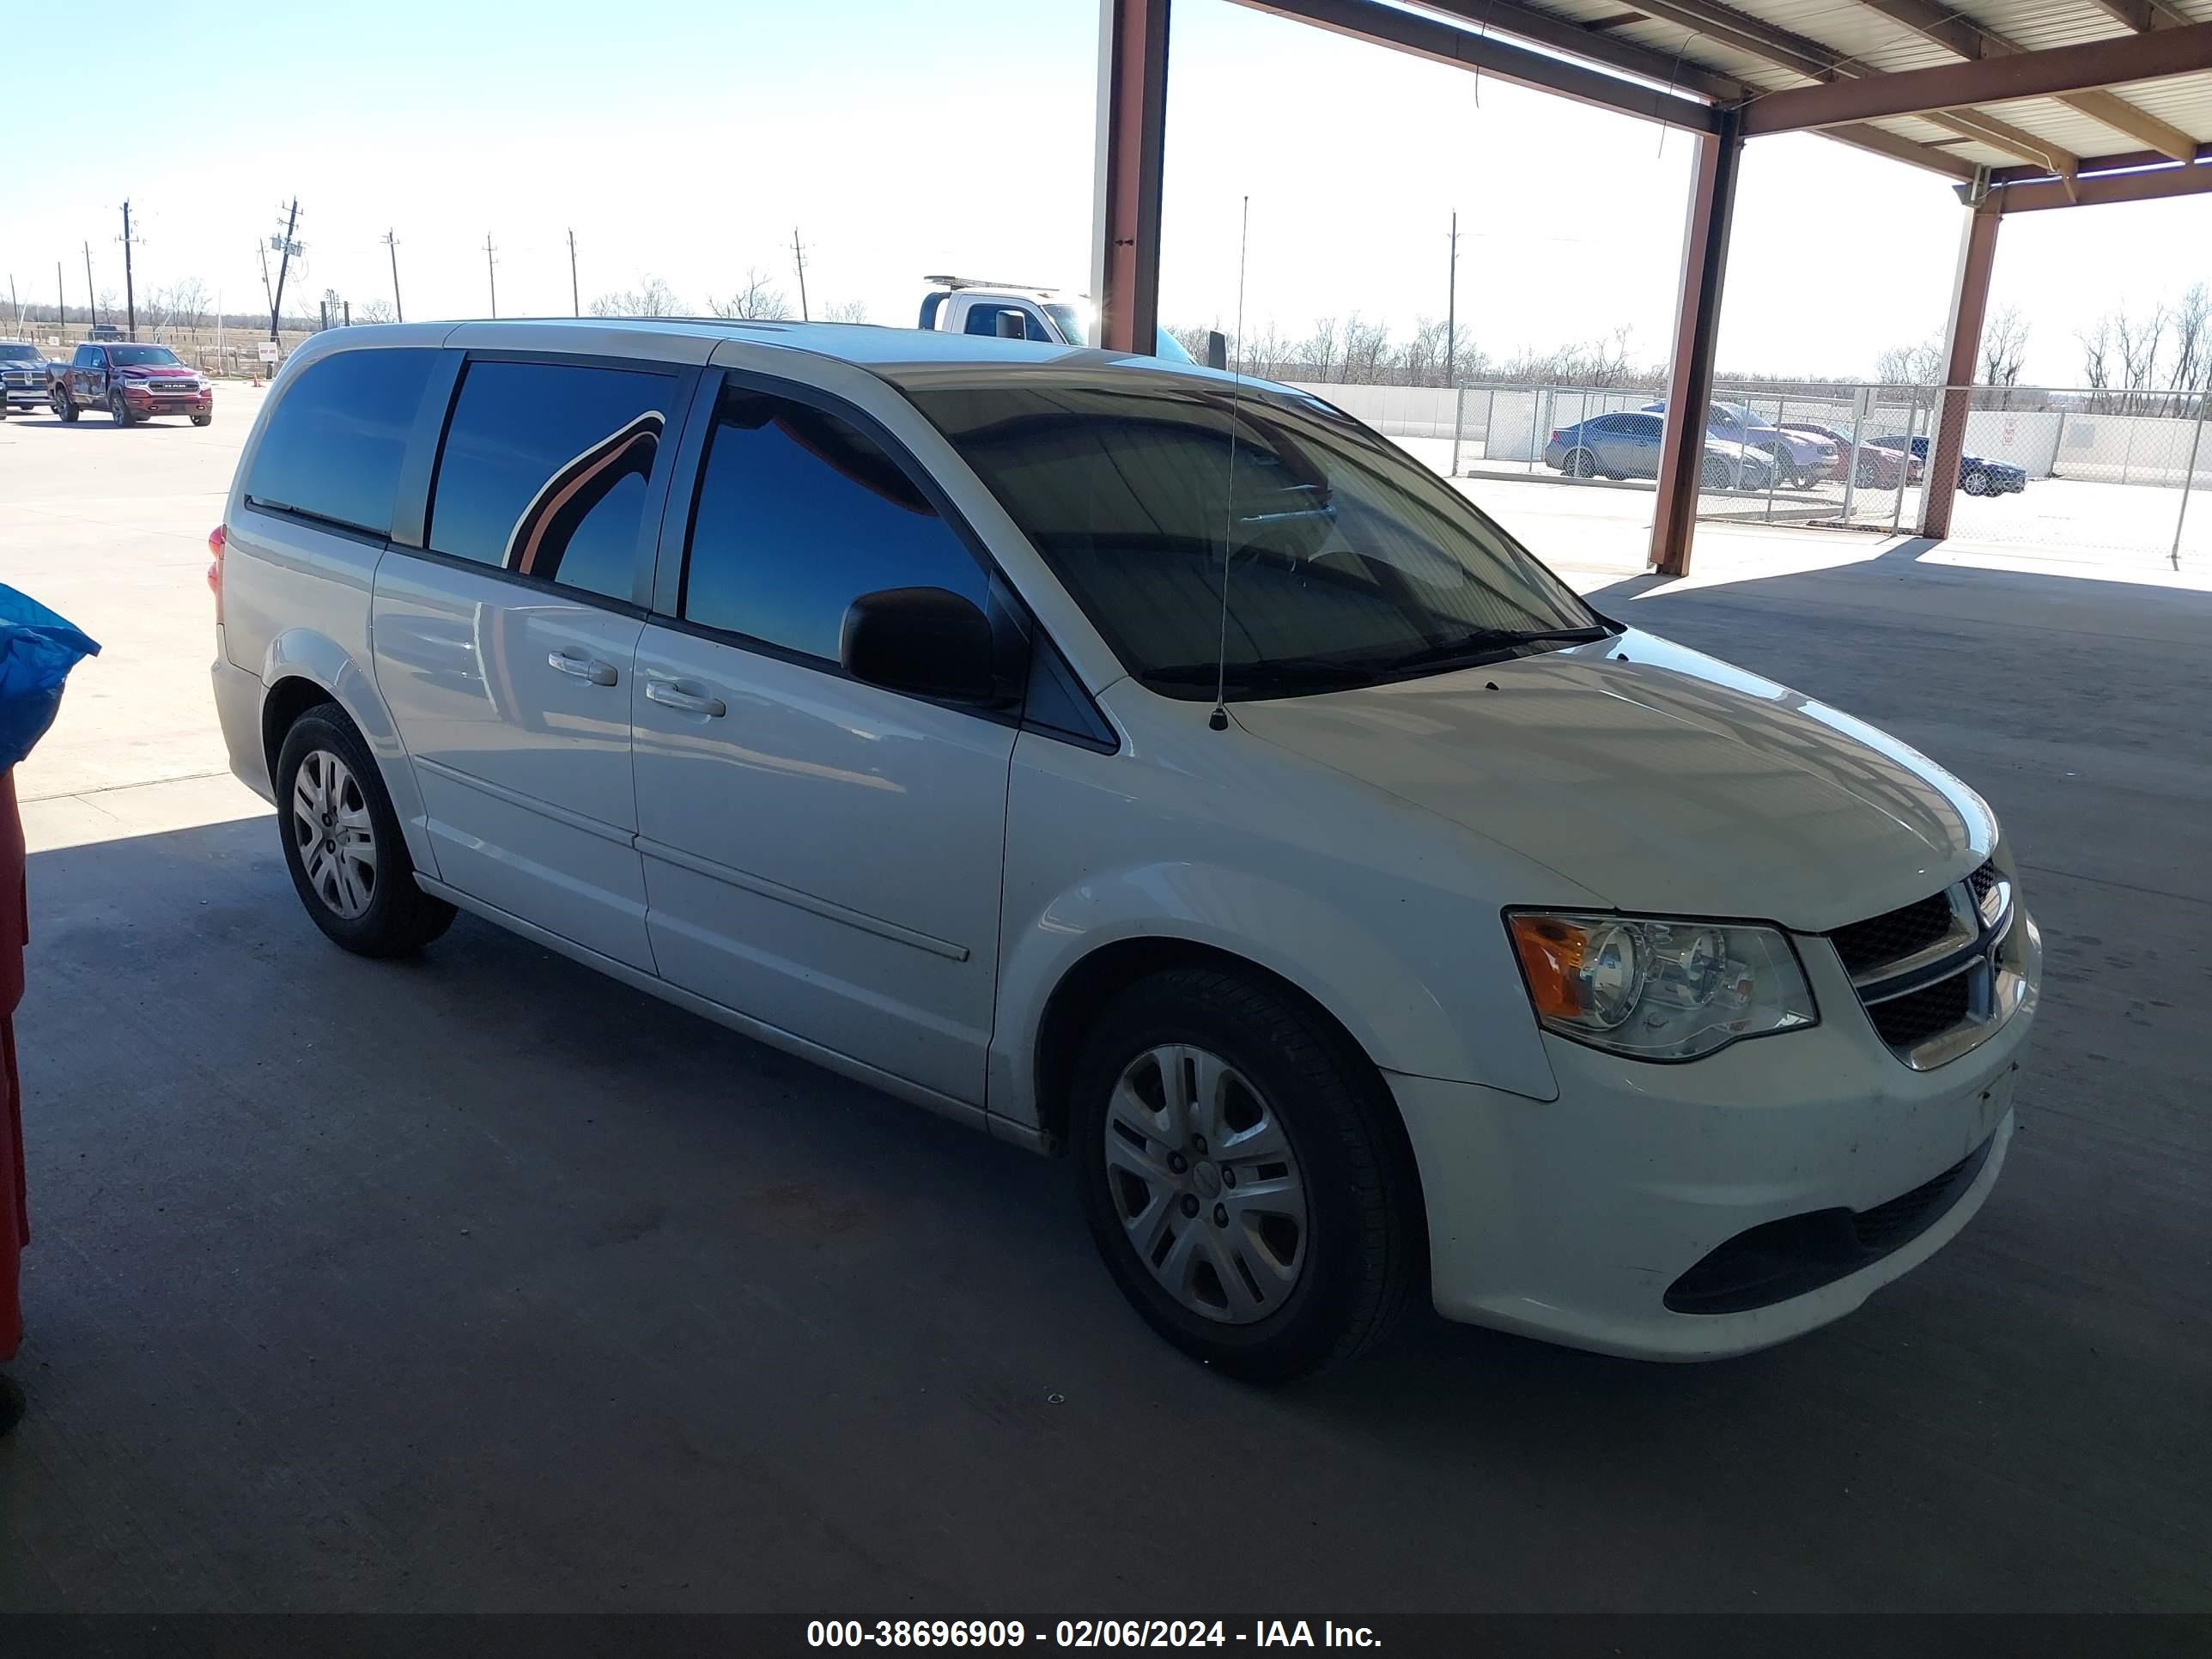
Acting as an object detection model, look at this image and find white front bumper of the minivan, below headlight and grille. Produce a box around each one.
[1389,924,2039,1360]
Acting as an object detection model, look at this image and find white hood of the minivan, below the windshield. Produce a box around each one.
[1234,630,1997,933]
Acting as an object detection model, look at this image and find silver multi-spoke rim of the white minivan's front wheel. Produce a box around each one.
[1103,1044,1307,1325]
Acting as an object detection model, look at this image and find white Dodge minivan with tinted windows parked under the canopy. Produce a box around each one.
[210,321,2042,1380]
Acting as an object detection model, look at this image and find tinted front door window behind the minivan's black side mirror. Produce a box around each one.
[681,389,988,661]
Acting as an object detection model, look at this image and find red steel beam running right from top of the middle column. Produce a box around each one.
[1743,22,2212,137]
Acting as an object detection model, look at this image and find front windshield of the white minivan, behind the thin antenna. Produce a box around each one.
[900,365,1610,699]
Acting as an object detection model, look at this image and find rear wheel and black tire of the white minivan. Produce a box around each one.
[276,703,453,956]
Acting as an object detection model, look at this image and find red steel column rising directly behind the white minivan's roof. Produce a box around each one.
[1091,0,1168,356]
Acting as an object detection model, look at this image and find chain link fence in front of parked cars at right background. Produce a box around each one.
[1310,380,2212,568]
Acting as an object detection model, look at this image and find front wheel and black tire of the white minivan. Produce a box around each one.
[1068,967,1427,1382]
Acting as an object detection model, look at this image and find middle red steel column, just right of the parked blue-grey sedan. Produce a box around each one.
[1652,112,1743,575]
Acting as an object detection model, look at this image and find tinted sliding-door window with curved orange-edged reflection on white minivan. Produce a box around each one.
[429,358,677,599]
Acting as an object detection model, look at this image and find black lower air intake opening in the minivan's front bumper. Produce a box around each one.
[1663,1139,1996,1314]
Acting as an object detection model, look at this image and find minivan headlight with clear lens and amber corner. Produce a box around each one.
[1506,911,1820,1060]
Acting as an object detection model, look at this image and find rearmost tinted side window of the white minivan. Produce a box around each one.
[246,349,438,535]
